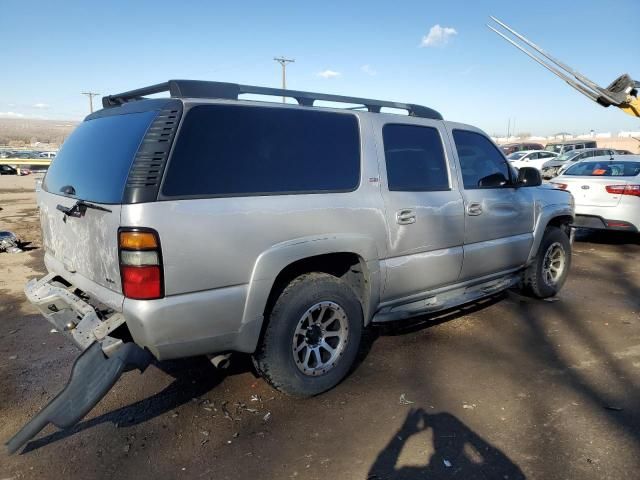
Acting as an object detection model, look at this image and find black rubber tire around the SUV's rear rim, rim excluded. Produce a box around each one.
[253,272,363,397]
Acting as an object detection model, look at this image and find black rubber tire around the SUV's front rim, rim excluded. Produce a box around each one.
[523,227,571,298]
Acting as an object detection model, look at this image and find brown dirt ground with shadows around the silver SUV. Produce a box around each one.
[0,177,640,480]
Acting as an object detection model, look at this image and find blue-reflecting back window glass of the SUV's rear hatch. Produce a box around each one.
[42,111,158,203]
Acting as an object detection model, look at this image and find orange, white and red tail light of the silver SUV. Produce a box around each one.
[118,228,164,300]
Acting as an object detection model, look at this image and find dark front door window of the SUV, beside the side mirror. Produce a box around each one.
[453,130,511,189]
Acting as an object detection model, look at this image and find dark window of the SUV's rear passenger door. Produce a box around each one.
[382,124,449,192]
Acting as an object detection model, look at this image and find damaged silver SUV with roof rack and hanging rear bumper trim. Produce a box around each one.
[6,81,574,449]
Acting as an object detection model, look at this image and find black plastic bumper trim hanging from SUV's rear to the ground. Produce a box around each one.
[6,342,152,453]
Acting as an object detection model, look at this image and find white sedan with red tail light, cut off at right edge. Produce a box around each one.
[551,155,640,232]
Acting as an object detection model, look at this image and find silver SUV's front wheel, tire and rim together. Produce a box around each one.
[524,227,571,298]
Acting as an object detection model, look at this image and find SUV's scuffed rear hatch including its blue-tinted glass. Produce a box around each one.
[38,108,165,293]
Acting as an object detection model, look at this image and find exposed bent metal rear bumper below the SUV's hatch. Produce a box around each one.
[24,273,125,355]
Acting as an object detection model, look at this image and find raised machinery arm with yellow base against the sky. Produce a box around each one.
[487,17,640,118]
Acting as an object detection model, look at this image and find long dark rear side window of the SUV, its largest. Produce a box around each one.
[162,105,360,197]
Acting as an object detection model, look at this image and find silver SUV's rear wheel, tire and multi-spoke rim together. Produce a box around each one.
[254,273,362,397]
